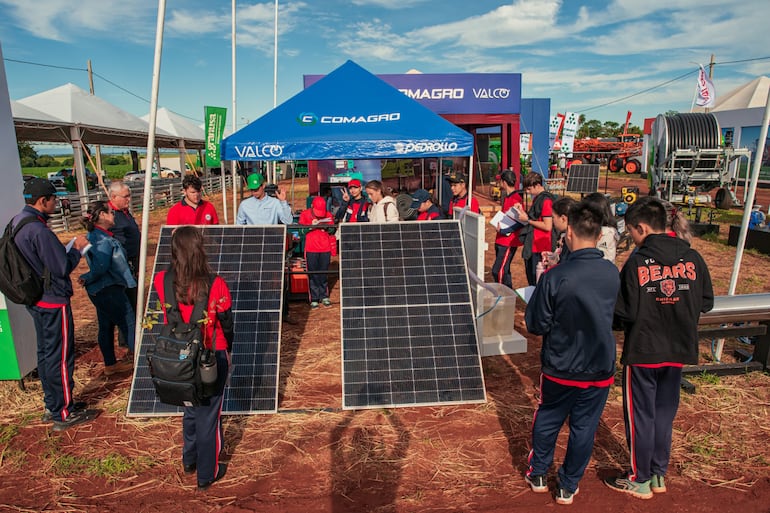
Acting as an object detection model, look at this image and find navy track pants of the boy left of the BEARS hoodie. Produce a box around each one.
[527,374,610,492]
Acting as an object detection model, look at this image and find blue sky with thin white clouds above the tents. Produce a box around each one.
[0,0,770,135]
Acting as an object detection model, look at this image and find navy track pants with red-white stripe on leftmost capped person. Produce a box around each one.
[27,304,75,420]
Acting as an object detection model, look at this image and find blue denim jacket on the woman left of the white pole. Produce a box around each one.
[80,228,136,296]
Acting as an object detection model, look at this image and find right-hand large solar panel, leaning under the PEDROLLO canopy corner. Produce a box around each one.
[340,220,486,410]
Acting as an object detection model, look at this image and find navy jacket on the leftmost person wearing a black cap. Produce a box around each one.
[13,205,80,307]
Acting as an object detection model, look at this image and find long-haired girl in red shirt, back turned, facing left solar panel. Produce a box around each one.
[153,226,233,490]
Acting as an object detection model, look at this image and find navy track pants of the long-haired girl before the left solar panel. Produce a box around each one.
[182,351,229,484]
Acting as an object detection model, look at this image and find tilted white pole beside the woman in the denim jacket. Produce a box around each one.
[134,0,166,352]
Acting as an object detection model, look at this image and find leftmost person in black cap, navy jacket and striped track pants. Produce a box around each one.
[12,178,96,431]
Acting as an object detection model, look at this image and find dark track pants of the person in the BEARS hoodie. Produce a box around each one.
[623,365,682,482]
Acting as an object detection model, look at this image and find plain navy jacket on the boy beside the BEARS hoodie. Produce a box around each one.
[525,248,620,381]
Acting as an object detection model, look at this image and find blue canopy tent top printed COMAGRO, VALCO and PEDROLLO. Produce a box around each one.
[222,61,473,160]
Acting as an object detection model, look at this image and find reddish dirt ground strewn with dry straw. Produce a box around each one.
[0,176,770,513]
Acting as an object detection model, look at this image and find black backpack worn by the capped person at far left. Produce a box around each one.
[0,216,50,306]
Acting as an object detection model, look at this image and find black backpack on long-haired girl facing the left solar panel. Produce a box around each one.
[147,271,216,406]
